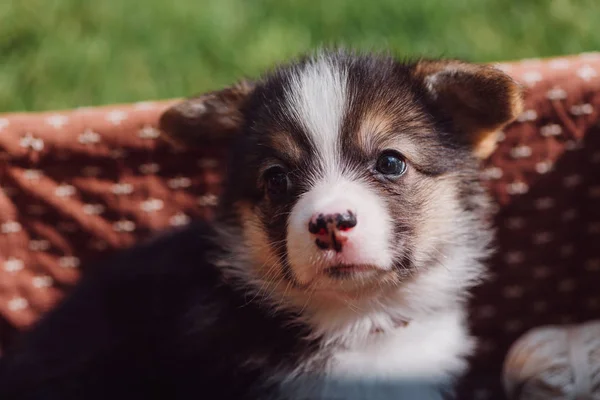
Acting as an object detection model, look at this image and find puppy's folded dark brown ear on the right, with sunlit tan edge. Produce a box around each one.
[415,60,523,158]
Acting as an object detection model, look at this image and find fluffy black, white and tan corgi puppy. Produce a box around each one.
[0,50,522,400]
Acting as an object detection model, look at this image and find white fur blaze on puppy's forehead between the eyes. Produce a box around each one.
[286,54,348,172]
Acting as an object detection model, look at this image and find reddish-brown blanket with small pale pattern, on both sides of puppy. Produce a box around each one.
[0,53,600,399]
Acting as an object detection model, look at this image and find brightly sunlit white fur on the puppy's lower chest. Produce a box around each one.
[328,312,473,381]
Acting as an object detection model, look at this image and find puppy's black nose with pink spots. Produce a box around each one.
[308,210,358,253]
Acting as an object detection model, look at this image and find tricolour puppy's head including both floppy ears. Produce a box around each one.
[161,53,521,295]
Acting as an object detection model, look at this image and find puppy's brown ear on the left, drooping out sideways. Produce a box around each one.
[159,81,254,147]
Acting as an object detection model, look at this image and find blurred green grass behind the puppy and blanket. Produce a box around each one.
[0,0,600,112]
